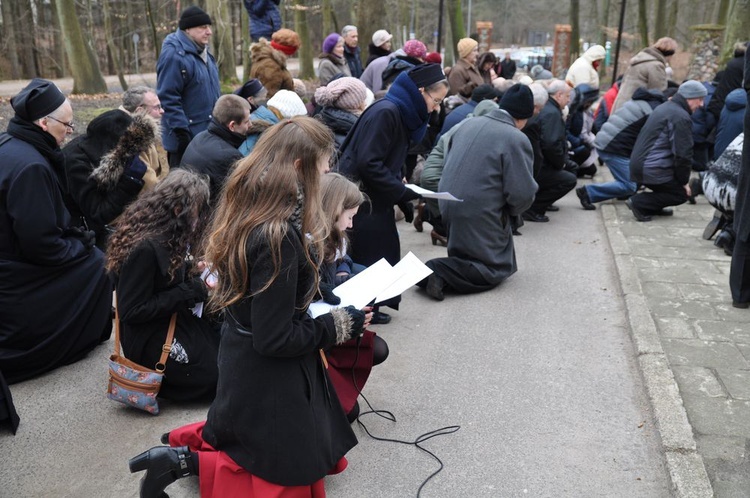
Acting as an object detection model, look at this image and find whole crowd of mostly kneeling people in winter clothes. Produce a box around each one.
[0,1,750,498]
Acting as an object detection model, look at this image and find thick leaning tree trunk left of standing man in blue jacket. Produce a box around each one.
[57,0,107,93]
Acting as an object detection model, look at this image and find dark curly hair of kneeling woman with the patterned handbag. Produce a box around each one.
[106,169,209,278]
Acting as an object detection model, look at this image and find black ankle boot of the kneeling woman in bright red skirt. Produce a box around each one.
[128,446,198,498]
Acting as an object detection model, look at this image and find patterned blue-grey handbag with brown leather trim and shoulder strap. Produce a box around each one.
[107,298,177,415]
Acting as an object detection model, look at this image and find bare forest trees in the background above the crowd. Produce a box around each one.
[0,0,750,94]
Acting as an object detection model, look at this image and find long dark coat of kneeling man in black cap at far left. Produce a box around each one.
[0,130,112,383]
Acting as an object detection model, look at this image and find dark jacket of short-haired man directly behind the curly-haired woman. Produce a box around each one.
[180,119,245,206]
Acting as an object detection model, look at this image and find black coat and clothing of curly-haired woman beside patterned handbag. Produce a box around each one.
[116,240,219,401]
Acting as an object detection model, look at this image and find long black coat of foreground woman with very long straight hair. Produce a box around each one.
[203,225,357,486]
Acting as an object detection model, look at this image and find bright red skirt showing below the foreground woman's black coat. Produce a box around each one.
[169,421,347,498]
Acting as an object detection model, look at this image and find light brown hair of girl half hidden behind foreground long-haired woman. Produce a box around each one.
[321,173,365,263]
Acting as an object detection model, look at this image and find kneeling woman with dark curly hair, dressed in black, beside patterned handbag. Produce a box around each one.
[106,169,219,401]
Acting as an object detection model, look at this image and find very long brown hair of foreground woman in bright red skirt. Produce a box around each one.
[206,116,334,310]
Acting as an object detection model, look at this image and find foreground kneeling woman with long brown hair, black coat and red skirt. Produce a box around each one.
[130,117,365,498]
